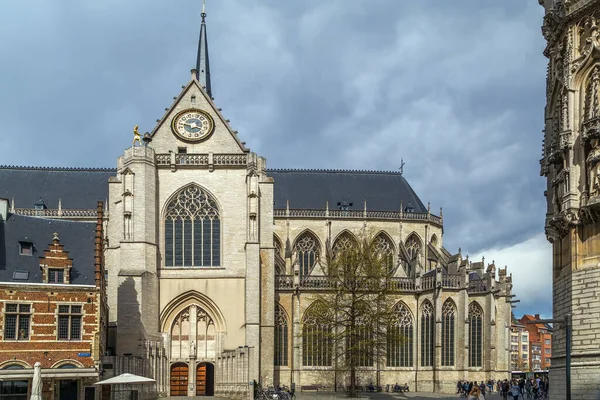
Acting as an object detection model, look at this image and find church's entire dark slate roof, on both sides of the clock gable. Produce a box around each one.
[0,167,427,212]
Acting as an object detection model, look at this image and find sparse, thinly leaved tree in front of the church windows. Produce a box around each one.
[305,237,403,397]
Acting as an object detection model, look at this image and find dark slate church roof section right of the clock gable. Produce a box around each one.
[267,169,427,212]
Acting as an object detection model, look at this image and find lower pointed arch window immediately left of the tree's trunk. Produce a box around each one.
[302,302,332,367]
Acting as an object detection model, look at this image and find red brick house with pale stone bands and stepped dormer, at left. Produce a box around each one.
[0,199,108,400]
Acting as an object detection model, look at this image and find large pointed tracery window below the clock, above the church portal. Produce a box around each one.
[165,185,221,268]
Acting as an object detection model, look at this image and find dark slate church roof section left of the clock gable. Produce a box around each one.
[0,166,116,209]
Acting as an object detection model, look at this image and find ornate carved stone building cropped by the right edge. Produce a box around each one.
[539,0,600,399]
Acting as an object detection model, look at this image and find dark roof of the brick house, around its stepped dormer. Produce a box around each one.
[0,214,96,285]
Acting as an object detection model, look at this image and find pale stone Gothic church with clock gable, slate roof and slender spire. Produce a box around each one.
[0,8,513,396]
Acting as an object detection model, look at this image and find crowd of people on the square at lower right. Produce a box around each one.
[456,377,549,400]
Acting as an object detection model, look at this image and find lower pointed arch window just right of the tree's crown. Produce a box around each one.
[386,302,413,367]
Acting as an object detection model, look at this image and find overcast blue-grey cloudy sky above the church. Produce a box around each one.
[0,0,552,316]
